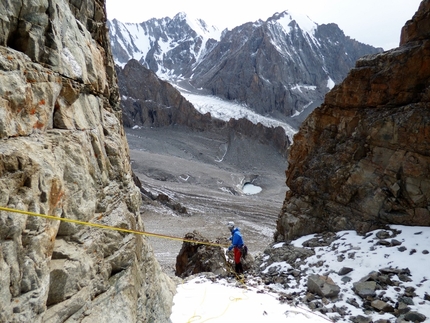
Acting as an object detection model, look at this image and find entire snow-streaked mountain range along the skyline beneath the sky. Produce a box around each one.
[109,11,382,119]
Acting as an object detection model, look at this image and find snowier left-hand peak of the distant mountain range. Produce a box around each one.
[108,13,221,79]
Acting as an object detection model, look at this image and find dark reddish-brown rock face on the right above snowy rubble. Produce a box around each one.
[275,0,430,240]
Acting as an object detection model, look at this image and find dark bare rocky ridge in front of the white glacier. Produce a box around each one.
[117,59,290,154]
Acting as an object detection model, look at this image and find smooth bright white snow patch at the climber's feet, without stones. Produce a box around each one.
[170,277,327,323]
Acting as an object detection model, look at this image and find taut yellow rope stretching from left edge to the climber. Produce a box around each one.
[0,206,228,248]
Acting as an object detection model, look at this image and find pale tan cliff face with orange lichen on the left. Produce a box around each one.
[0,0,174,322]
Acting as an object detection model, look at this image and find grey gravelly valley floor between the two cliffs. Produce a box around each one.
[127,127,287,275]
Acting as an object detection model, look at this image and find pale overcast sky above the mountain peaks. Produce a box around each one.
[106,0,421,50]
